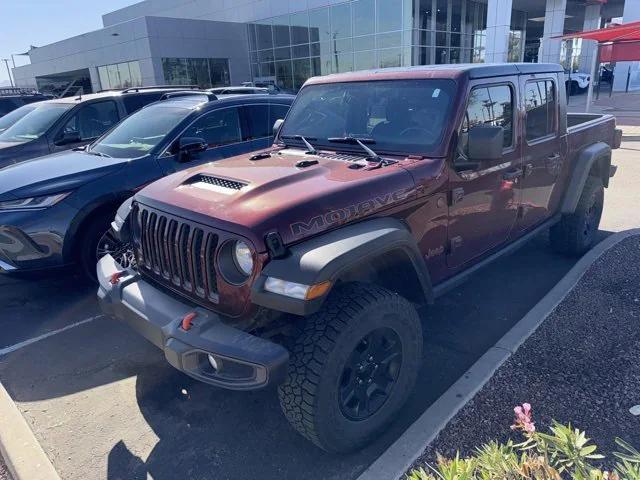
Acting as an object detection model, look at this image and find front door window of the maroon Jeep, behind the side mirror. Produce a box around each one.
[460,85,514,155]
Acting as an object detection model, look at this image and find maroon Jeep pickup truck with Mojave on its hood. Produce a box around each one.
[97,64,621,452]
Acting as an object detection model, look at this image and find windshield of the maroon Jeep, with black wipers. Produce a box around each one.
[280,79,455,154]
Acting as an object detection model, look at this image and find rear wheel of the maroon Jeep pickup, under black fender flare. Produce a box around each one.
[549,176,604,256]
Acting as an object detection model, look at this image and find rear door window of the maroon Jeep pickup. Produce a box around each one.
[524,80,556,141]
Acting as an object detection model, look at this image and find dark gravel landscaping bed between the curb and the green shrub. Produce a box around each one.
[416,236,640,466]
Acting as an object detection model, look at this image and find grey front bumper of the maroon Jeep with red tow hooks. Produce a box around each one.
[97,255,289,390]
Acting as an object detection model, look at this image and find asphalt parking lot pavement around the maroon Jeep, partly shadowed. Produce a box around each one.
[0,137,640,480]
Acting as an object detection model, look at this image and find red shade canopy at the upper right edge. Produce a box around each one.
[561,22,640,62]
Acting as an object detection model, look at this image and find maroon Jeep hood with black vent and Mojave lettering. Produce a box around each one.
[136,149,428,251]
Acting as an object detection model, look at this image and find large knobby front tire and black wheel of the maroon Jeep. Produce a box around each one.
[278,283,422,452]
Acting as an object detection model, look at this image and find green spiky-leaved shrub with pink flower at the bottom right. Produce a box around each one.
[405,403,640,480]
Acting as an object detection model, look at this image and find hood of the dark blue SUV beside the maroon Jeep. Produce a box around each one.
[0,151,128,200]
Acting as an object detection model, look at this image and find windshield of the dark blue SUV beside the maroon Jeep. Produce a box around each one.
[89,104,193,158]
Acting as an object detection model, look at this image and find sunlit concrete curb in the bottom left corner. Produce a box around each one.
[0,383,60,480]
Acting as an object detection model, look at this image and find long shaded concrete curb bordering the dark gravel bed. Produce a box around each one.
[357,228,640,480]
